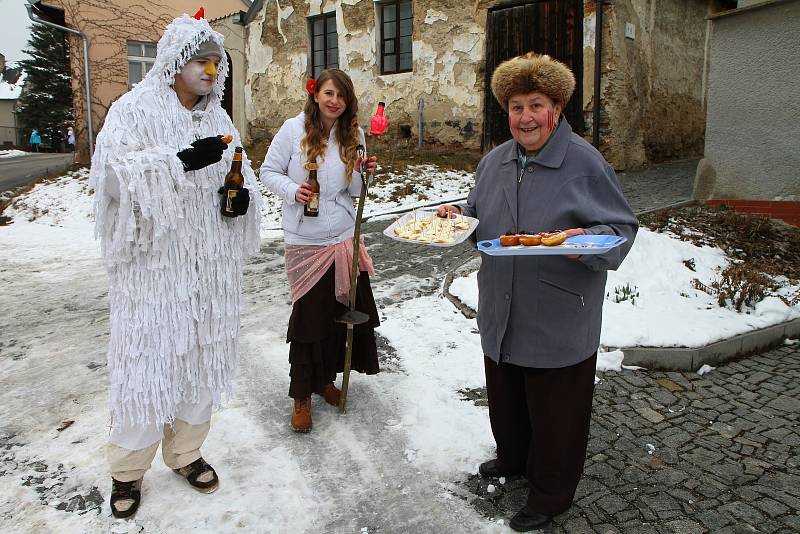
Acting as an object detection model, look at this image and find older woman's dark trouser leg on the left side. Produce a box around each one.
[484,356,531,472]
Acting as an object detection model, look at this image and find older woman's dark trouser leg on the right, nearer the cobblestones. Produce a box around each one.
[525,353,597,515]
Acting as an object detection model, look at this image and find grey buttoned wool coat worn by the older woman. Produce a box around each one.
[460,119,638,368]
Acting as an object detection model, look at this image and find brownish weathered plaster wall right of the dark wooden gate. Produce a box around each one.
[584,0,707,169]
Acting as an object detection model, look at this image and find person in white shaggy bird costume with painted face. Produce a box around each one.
[90,12,262,517]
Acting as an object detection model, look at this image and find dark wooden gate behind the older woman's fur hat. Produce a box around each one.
[483,0,584,151]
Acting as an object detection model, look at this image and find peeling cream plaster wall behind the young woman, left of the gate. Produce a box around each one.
[246,0,486,148]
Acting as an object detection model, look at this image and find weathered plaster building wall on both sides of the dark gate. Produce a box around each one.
[245,0,707,169]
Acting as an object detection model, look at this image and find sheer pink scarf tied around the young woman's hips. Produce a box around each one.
[284,236,375,305]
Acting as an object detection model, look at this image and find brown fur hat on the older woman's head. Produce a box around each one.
[492,52,575,111]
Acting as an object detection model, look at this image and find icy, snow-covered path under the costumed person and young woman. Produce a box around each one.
[0,224,505,533]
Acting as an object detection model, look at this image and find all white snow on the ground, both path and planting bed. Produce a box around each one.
[0,170,800,533]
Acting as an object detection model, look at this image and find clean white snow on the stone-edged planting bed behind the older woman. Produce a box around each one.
[450,228,800,348]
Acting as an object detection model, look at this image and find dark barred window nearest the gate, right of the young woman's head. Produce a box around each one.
[378,0,413,74]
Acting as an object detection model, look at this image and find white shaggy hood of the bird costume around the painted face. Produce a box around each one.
[138,15,228,100]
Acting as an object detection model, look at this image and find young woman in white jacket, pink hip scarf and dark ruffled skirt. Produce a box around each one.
[261,69,379,432]
